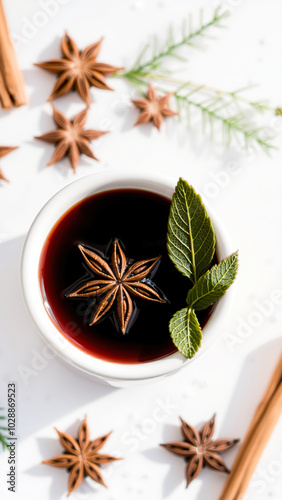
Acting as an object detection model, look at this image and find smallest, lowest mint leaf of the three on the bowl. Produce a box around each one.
[169,307,202,358]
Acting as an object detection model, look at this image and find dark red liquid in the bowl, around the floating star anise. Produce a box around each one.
[39,189,214,363]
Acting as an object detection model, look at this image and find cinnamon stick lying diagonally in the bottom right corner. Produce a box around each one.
[219,356,282,500]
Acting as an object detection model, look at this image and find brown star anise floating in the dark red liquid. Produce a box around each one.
[67,239,166,334]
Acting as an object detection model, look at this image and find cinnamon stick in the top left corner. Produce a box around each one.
[0,0,27,109]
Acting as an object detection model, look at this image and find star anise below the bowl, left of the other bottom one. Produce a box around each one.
[42,417,121,495]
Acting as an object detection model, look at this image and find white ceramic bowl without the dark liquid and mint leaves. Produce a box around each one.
[21,171,232,387]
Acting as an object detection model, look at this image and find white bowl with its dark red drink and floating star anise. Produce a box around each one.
[21,171,235,387]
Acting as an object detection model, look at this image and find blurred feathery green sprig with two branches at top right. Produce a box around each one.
[114,7,273,152]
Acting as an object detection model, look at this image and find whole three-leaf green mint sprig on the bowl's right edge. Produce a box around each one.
[167,179,238,358]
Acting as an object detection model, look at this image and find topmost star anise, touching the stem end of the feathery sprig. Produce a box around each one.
[35,33,123,106]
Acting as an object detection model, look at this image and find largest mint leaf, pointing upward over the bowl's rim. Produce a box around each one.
[167,179,215,283]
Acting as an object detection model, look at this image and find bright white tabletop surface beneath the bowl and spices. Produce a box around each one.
[0,0,282,500]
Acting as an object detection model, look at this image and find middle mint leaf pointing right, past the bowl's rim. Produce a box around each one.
[186,252,238,311]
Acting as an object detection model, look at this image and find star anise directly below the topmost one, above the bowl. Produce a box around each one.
[35,105,107,171]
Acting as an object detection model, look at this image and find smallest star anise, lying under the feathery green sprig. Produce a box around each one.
[132,83,178,130]
